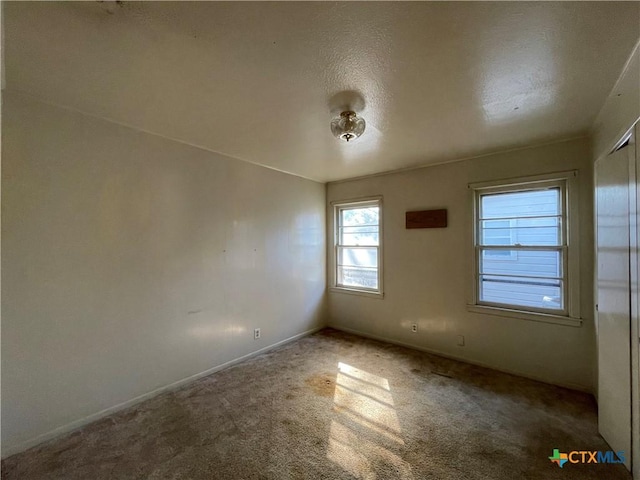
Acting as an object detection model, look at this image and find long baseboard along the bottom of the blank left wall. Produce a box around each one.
[2,325,326,459]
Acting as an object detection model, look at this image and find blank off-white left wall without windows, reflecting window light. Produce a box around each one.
[2,92,326,455]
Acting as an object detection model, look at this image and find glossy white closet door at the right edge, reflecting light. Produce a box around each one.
[596,148,631,468]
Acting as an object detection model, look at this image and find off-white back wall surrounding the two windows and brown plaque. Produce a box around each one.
[327,139,594,391]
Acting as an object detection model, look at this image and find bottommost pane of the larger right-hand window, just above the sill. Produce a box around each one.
[480,275,563,310]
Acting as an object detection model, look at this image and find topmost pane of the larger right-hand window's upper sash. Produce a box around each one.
[480,188,562,219]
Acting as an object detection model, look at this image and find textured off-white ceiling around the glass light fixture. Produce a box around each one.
[4,2,640,181]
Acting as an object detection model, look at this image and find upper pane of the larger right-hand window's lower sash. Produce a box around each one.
[480,249,562,277]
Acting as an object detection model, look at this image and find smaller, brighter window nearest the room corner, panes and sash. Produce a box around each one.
[334,199,382,294]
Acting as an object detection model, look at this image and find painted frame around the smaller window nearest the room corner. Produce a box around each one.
[329,196,384,298]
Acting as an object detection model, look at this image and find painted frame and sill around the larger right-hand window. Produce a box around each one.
[467,170,582,326]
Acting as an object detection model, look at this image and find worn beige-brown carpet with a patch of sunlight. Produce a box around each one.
[2,329,631,480]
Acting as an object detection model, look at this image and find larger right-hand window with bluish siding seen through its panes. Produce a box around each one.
[471,172,578,317]
